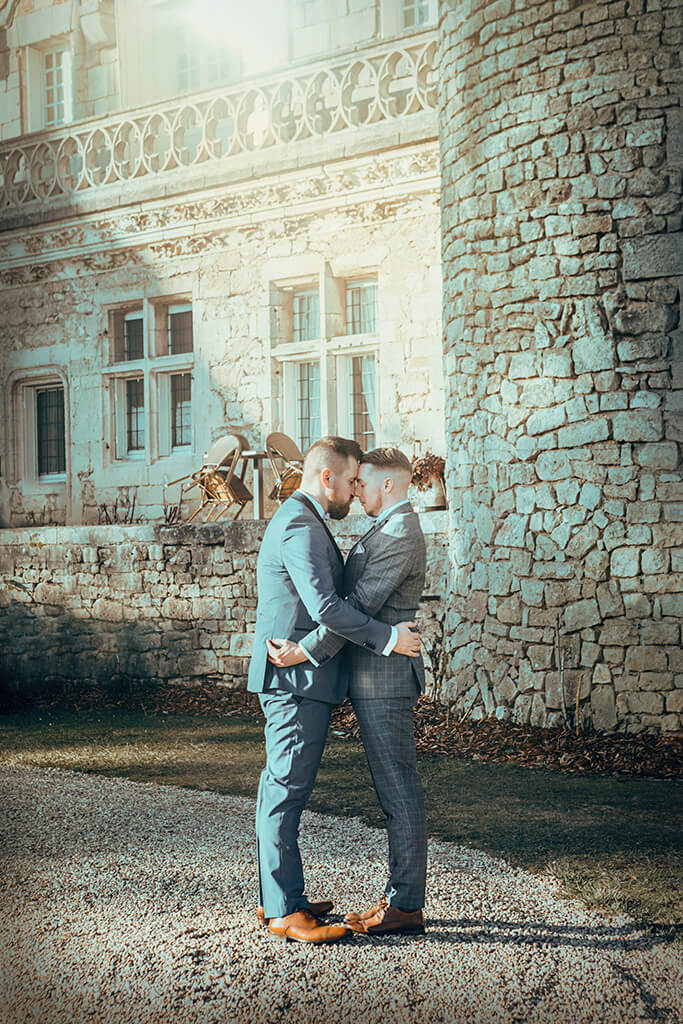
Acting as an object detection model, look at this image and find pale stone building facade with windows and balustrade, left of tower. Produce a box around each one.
[0,0,443,526]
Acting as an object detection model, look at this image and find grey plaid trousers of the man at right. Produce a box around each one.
[351,686,427,910]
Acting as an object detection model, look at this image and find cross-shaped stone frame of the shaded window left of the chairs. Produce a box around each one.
[101,294,197,472]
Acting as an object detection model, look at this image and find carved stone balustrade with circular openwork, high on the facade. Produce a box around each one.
[0,32,437,226]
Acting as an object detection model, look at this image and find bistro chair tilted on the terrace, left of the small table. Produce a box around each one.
[168,434,253,522]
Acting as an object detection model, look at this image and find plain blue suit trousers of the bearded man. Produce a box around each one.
[256,690,332,918]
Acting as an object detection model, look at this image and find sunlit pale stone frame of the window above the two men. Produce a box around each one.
[264,257,381,443]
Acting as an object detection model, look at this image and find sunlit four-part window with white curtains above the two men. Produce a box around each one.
[271,274,378,451]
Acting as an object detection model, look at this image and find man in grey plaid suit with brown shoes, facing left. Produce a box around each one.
[271,449,427,935]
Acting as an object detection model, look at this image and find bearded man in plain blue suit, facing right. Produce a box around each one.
[249,437,420,943]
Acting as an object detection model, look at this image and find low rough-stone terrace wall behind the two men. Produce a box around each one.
[0,513,446,692]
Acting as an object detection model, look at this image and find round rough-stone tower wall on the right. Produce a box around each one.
[440,0,683,731]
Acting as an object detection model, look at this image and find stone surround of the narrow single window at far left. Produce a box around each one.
[7,365,71,496]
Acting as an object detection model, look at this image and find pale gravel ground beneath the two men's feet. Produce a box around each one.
[0,766,683,1024]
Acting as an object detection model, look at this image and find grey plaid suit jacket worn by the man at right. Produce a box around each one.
[302,504,427,698]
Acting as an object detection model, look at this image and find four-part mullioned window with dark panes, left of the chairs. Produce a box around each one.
[104,300,194,460]
